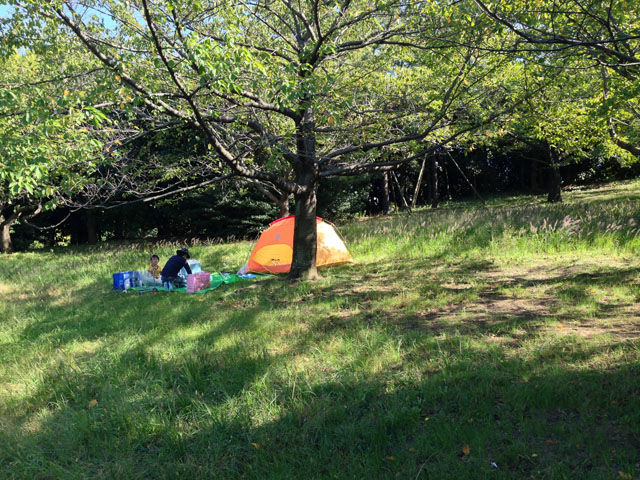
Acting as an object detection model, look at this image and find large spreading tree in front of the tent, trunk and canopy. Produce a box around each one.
[8,0,520,278]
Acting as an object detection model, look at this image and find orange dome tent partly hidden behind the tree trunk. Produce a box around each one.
[239,215,352,273]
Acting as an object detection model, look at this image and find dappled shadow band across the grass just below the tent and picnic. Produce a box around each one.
[7,251,640,356]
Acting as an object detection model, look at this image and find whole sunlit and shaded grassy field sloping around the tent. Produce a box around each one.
[0,182,640,480]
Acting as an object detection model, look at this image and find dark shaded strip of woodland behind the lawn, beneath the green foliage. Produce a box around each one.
[14,151,640,250]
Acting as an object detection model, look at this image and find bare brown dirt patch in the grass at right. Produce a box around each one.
[405,259,640,342]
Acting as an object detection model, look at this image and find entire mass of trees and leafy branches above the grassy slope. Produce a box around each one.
[0,0,640,262]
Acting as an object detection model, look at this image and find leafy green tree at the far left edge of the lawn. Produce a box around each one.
[0,45,104,252]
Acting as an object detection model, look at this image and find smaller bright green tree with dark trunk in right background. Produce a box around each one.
[467,57,608,202]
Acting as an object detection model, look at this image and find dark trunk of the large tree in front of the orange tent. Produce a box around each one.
[289,108,318,280]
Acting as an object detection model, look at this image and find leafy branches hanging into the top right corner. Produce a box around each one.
[474,0,640,157]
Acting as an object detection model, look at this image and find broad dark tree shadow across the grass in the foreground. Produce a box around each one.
[0,339,640,479]
